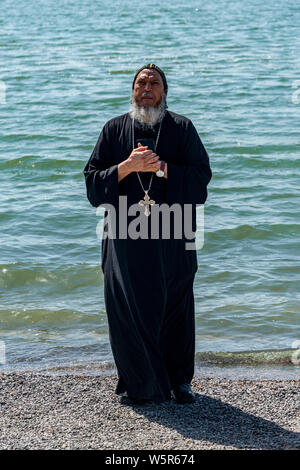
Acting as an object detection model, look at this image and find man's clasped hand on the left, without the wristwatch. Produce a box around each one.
[118,143,160,181]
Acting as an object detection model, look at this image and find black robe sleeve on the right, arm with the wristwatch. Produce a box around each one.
[167,121,212,204]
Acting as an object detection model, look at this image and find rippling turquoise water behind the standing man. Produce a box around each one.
[0,0,300,374]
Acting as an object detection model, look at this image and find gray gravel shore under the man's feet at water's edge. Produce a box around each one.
[0,373,300,450]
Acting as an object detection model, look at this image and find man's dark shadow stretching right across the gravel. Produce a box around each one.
[130,393,300,450]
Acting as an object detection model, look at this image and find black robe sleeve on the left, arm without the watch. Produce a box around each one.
[84,124,119,207]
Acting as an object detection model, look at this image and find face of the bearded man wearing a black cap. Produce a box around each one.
[133,69,164,107]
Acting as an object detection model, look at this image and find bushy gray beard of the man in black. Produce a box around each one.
[129,94,168,128]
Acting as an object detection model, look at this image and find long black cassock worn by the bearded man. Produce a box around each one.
[84,111,212,402]
